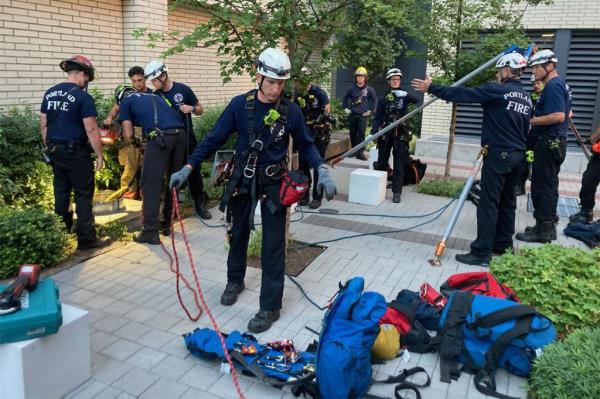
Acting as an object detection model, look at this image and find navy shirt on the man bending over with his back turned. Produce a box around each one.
[119,93,184,134]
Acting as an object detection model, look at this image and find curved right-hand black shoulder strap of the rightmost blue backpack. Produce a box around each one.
[474,314,534,399]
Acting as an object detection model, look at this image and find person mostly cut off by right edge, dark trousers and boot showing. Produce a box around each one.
[569,127,600,224]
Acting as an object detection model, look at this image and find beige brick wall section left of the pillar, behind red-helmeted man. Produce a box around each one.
[0,0,124,108]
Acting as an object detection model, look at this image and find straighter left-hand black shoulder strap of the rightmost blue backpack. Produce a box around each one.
[438,291,473,382]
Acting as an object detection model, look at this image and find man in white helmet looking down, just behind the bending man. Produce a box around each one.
[144,60,212,219]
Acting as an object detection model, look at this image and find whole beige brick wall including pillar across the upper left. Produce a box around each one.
[0,0,254,111]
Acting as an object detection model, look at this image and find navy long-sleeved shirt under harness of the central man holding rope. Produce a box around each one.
[188,94,323,168]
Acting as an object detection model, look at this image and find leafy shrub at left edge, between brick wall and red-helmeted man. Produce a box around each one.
[0,107,53,209]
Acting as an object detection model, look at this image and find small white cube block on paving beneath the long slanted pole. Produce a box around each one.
[348,169,387,205]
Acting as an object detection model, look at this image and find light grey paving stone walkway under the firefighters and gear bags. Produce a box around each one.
[58,179,583,399]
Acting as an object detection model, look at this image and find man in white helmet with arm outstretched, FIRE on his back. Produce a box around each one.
[412,53,532,266]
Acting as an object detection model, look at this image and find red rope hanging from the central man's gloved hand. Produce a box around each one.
[166,187,245,399]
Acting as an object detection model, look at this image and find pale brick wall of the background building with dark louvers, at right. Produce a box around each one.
[421,0,600,137]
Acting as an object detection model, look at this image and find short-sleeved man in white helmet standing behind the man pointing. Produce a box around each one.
[517,50,571,243]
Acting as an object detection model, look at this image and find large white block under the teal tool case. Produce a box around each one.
[0,303,91,399]
